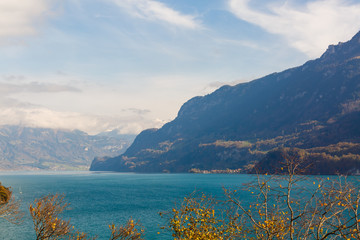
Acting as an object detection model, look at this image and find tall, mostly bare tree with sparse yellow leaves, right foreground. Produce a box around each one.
[225,155,360,240]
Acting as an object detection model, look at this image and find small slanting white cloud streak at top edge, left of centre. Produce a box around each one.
[113,0,200,29]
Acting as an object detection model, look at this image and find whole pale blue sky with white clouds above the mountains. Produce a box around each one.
[0,0,360,134]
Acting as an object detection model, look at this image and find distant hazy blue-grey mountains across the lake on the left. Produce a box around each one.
[0,126,134,170]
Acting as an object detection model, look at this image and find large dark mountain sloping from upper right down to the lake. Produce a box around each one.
[90,32,360,172]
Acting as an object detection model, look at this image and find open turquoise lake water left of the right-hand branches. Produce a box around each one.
[0,172,253,240]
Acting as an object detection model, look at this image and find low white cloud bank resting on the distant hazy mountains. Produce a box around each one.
[0,104,163,134]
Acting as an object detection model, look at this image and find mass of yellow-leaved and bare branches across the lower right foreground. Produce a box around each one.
[162,152,360,240]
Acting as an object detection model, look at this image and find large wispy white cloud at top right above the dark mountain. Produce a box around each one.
[229,0,360,57]
